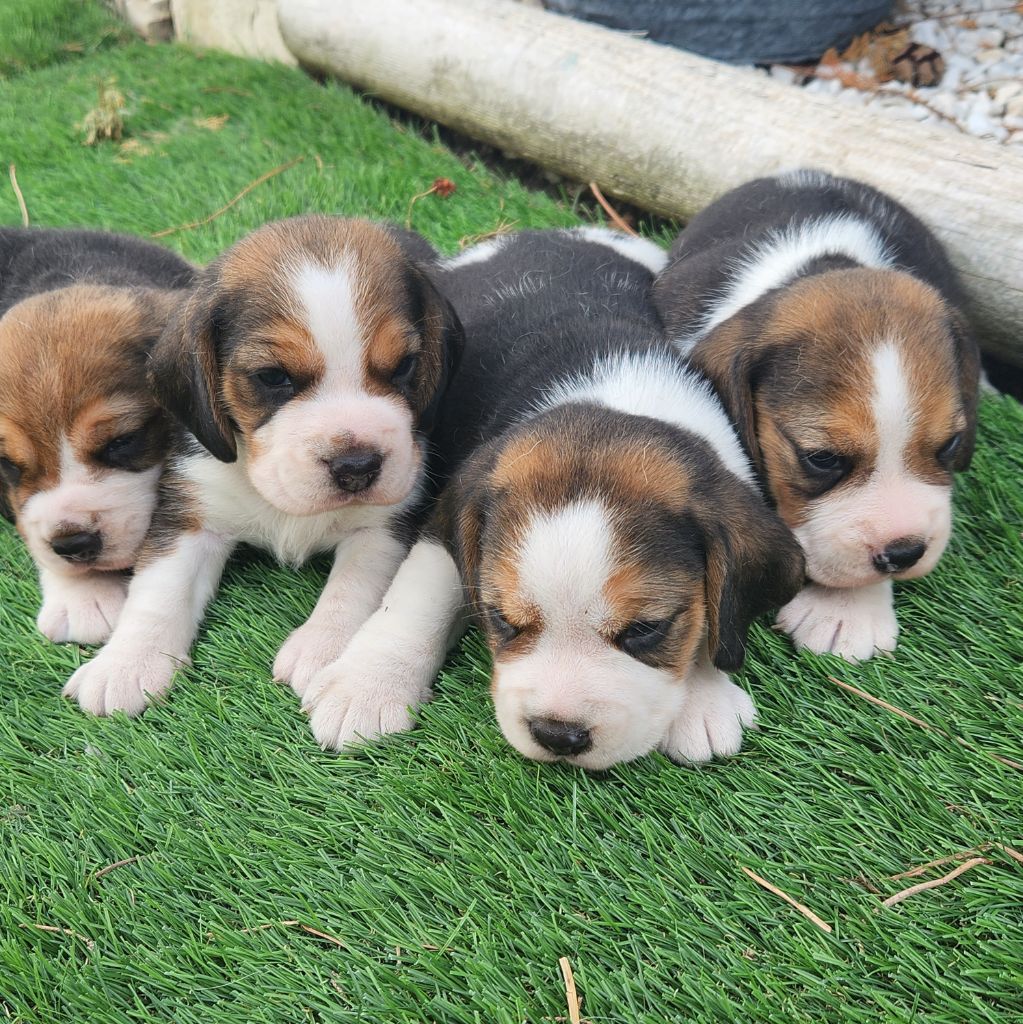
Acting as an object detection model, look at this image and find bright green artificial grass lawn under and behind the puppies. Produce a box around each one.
[0,0,1023,1024]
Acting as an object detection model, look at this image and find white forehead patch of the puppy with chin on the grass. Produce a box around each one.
[518,500,614,628]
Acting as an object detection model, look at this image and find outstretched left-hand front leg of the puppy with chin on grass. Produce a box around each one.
[306,540,464,750]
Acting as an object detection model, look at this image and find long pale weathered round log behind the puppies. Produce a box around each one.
[279,0,1023,365]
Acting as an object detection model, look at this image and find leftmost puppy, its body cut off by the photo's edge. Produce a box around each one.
[0,228,195,643]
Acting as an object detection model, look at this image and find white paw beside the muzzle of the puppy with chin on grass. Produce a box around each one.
[659,670,757,764]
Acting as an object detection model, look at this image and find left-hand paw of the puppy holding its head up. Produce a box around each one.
[61,644,178,718]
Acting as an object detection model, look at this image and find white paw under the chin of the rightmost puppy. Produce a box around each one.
[777,583,899,662]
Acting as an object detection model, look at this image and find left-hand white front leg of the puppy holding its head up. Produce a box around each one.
[63,530,233,716]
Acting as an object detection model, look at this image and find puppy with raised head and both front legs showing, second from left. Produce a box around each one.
[65,216,461,715]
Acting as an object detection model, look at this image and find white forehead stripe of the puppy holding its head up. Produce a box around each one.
[293,259,367,391]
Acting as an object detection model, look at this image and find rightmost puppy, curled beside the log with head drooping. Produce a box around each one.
[654,171,978,660]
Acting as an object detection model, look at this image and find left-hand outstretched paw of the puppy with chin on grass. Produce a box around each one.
[306,631,433,751]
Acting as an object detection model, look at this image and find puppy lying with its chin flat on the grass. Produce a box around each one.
[308,228,803,769]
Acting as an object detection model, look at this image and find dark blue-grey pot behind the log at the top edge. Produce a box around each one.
[544,0,893,63]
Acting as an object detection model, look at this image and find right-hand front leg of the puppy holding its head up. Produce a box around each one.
[273,528,408,697]
